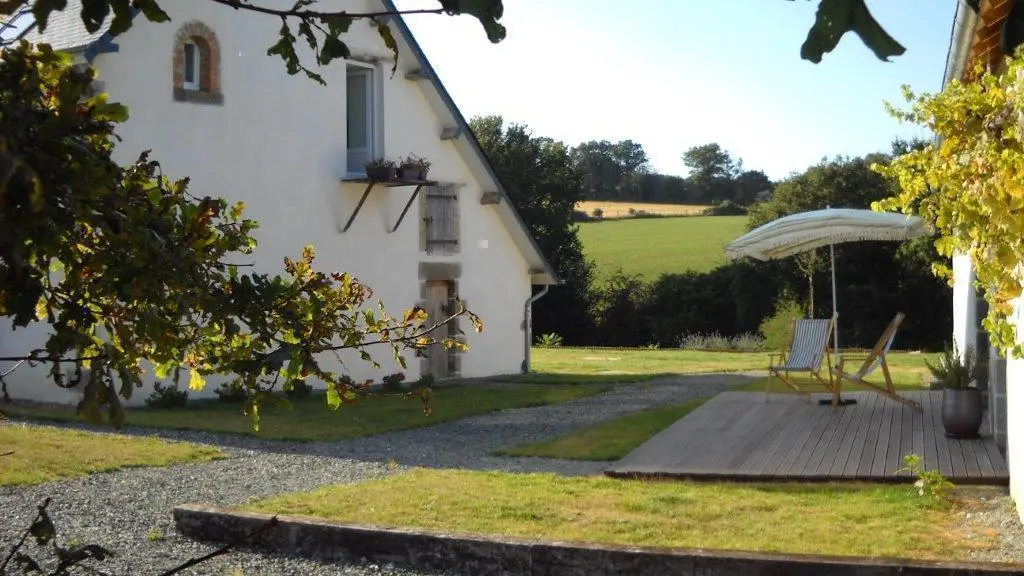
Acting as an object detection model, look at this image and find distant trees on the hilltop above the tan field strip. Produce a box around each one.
[571,140,773,206]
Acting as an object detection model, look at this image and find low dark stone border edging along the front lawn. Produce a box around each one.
[173,504,1024,576]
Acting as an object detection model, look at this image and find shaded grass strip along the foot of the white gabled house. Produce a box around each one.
[3,384,610,442]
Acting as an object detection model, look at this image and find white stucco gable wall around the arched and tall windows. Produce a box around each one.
[0,0,530,404]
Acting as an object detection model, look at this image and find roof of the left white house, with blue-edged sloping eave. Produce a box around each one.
[16,0,560,284]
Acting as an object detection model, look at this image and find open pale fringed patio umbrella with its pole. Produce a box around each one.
[725,203,929,387]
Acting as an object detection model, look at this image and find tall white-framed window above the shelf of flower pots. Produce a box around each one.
[345,63,379,175]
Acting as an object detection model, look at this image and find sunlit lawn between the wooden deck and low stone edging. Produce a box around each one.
[245,469,991,560]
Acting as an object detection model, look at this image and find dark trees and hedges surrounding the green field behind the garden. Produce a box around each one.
[471,116,952,349]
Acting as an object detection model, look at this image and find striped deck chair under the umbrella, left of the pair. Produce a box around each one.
[765,318,835,402]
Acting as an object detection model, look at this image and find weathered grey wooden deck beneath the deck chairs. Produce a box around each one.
[605,392,1010,485]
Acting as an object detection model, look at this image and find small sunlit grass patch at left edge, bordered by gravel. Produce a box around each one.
[0,422,222,486]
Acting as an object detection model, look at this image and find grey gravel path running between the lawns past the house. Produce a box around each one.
[0,375,742,576]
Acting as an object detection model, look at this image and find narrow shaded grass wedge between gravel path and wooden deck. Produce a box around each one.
[498,397,711,461]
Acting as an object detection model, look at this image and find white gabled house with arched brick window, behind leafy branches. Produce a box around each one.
[0,0,558,404]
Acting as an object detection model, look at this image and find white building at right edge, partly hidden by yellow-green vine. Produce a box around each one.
[943,0,1024,521]
